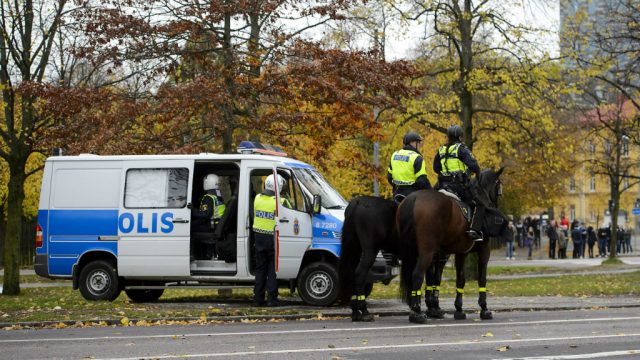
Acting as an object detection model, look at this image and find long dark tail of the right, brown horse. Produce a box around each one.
[398,196,418,303]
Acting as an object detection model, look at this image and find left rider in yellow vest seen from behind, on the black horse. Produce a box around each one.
[387,131,431,204]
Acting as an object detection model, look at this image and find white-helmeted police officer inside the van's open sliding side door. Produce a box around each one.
[192,174,226,259]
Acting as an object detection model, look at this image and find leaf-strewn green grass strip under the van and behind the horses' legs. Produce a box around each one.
[0,268,640,322]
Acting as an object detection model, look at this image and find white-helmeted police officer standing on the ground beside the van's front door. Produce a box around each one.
[253,174,285,306]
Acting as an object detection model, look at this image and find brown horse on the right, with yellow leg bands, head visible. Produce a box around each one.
[396,168,510,323]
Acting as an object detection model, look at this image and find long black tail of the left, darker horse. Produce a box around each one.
[338,198,362,302]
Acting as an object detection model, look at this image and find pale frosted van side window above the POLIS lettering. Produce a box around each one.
[124,168,189,209]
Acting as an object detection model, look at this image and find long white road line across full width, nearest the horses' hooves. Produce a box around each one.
[0,316,640,344]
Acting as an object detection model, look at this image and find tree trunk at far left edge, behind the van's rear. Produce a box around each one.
[3,158,26,295]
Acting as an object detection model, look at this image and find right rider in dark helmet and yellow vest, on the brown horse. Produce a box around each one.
[433,125,485,241]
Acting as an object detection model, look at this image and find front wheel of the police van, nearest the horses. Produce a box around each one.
[298,262,338,306]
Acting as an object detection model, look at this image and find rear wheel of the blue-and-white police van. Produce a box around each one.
[78,260,120,301]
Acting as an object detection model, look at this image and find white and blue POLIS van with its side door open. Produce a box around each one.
[35,142,395,305]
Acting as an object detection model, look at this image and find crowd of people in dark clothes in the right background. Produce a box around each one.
[505,212,633,259]
